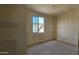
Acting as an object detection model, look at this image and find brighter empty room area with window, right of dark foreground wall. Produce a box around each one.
[26,4,79,55]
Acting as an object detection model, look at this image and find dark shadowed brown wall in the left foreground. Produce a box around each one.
[0,5,26,54]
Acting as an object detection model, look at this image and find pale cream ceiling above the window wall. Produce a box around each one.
[26,4,78,15]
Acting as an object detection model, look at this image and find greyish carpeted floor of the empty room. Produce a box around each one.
[27,40,78,55]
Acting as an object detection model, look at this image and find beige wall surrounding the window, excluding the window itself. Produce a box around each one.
[26,8,55,45]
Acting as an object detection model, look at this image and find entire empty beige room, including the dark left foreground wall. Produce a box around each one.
[0,4,79,55]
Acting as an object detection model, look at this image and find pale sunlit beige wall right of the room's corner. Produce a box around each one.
[57,8,79,46]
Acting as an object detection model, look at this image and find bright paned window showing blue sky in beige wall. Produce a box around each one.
[32,16,44,33]
